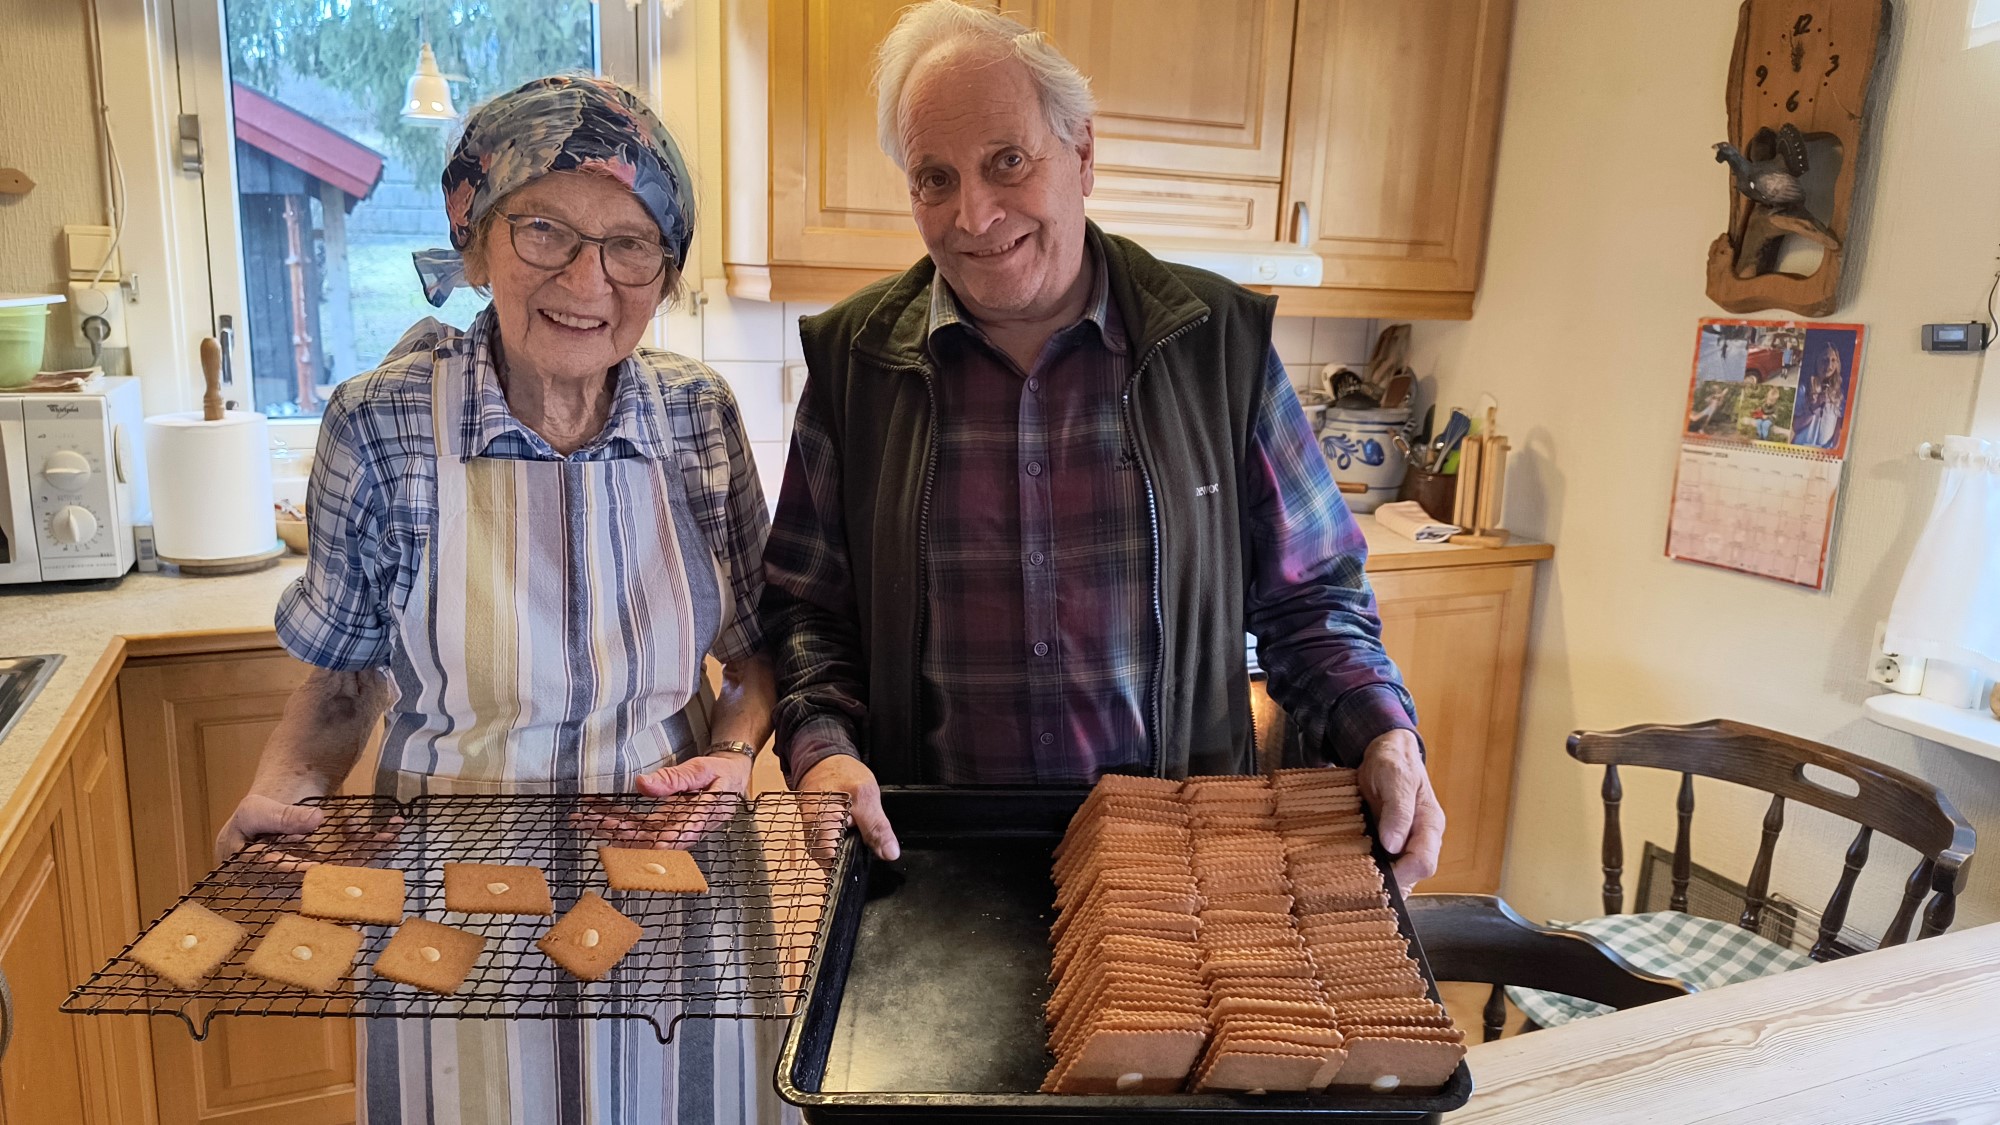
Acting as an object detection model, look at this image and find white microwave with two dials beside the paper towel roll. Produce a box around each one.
[0,376,146,583]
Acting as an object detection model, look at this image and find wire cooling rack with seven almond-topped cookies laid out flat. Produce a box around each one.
[62,793,854,1041]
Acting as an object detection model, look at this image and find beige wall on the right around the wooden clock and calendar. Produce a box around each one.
[1416,0,2000,931]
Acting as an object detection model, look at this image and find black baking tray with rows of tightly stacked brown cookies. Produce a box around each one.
[778,769,1472,1123]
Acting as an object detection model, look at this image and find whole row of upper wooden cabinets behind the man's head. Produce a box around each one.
[720,0,1512,318]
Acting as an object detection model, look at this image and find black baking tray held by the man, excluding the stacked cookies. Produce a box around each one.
[778,789,1472,1125]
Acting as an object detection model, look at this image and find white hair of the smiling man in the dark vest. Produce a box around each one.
[874,0,1098,168]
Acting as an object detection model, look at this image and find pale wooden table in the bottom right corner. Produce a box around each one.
[1446,925,2000,1125]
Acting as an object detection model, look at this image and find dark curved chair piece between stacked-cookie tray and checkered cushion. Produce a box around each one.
[1408,895,1694,1043]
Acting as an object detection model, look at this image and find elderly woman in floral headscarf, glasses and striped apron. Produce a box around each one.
[216,78,776,1125]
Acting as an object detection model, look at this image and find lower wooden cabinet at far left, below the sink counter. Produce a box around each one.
[0,684,156,1125]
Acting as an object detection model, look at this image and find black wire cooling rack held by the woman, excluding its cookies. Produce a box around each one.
[62,793,854,1043]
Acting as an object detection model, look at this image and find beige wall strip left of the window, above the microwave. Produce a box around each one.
[0,0,104,364]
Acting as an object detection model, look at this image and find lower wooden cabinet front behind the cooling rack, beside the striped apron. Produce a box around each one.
[118,649,372,1125]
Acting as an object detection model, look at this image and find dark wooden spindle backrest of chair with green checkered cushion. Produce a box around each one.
[1570,719,1976,961]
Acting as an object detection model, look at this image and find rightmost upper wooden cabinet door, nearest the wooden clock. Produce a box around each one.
[1276,0,1514,318]
